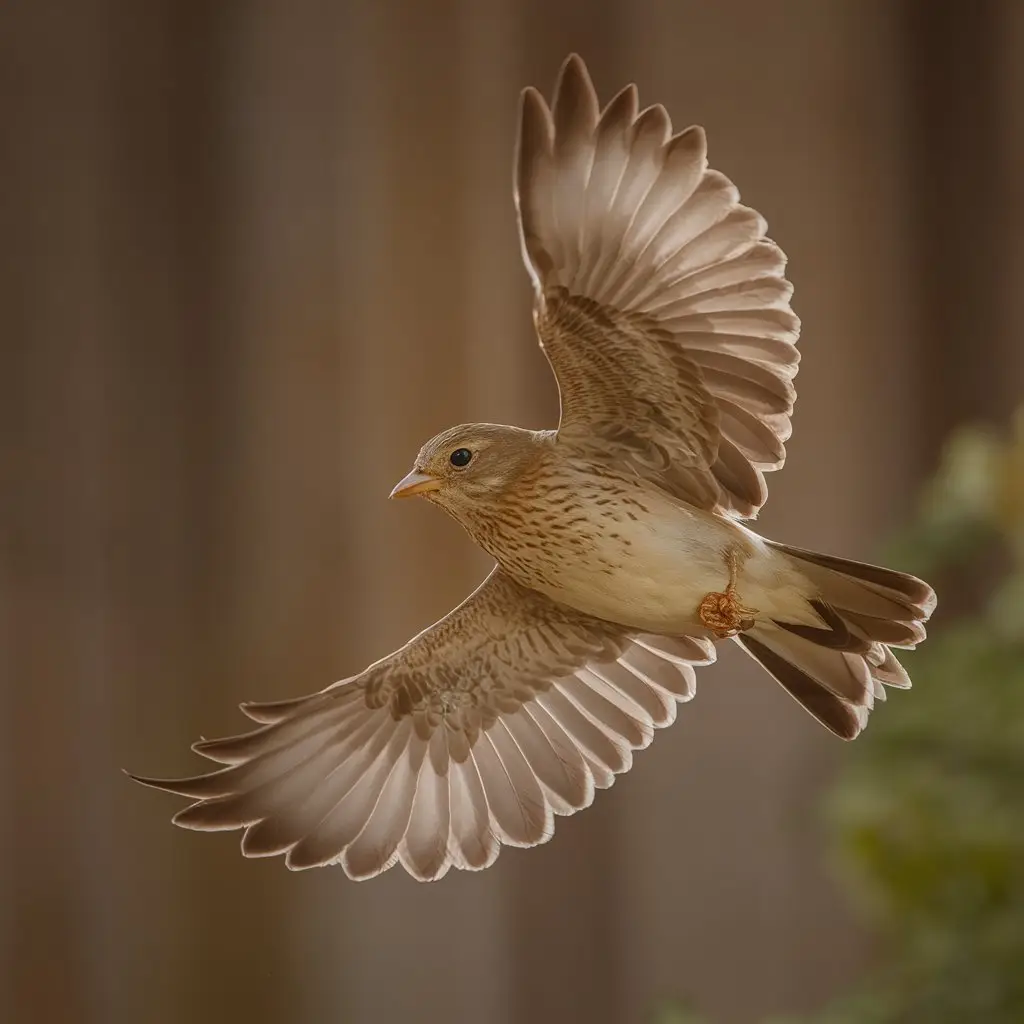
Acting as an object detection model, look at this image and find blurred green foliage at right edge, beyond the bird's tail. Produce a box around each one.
[664,411,1024,1024]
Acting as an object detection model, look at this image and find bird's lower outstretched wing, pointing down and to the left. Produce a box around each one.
[132,568,715,880]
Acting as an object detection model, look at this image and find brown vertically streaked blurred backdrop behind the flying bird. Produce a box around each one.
[0,0,1024,1024]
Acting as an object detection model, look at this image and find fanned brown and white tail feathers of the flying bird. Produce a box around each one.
[736,543,936,739]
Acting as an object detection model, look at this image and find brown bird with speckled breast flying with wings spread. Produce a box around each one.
[130,55,935,880]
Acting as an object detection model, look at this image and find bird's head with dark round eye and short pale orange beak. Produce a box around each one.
[391,423,546,518]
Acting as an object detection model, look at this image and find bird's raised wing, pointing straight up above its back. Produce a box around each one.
[515,55,800,516]
